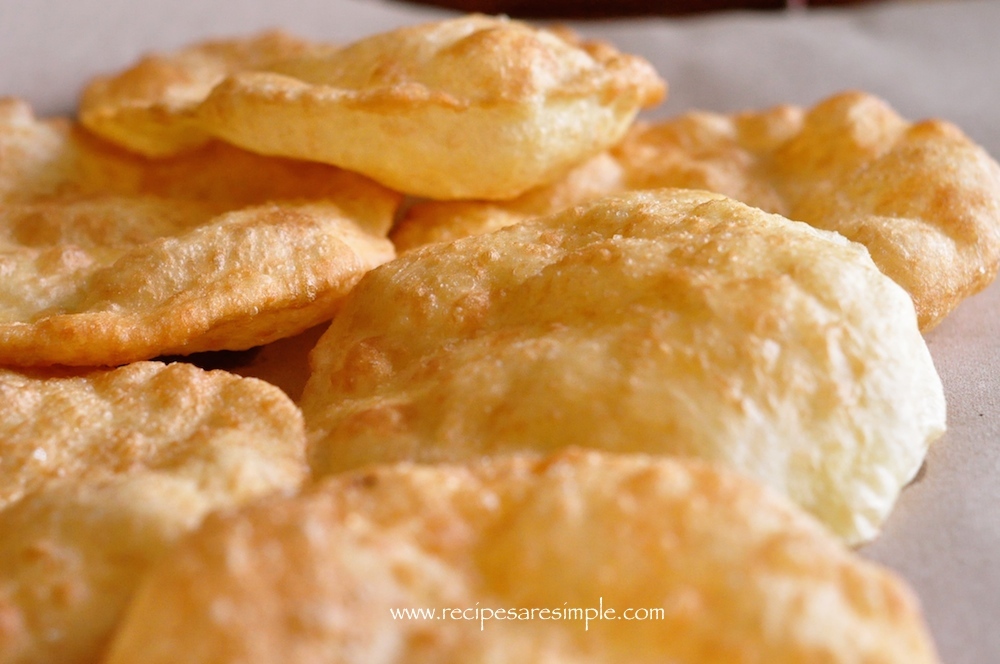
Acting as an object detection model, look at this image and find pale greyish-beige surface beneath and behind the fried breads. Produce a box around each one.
[0,0,1000,664]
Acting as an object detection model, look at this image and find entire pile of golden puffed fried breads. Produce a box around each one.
[0,15,1000,664]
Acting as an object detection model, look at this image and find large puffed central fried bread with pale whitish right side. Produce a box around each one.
[302,190,945,542]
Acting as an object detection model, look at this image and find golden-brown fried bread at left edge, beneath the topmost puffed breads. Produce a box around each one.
[0,100,400,366]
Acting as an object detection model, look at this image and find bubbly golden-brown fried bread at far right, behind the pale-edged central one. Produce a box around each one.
[615,92,1000,331]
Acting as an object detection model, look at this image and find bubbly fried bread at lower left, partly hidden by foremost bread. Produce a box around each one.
[0,362,306,664]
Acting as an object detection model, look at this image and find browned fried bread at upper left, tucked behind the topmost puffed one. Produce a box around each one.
[79,30,332,157]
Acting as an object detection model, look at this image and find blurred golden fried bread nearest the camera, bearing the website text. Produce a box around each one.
[101,451,937,664]
